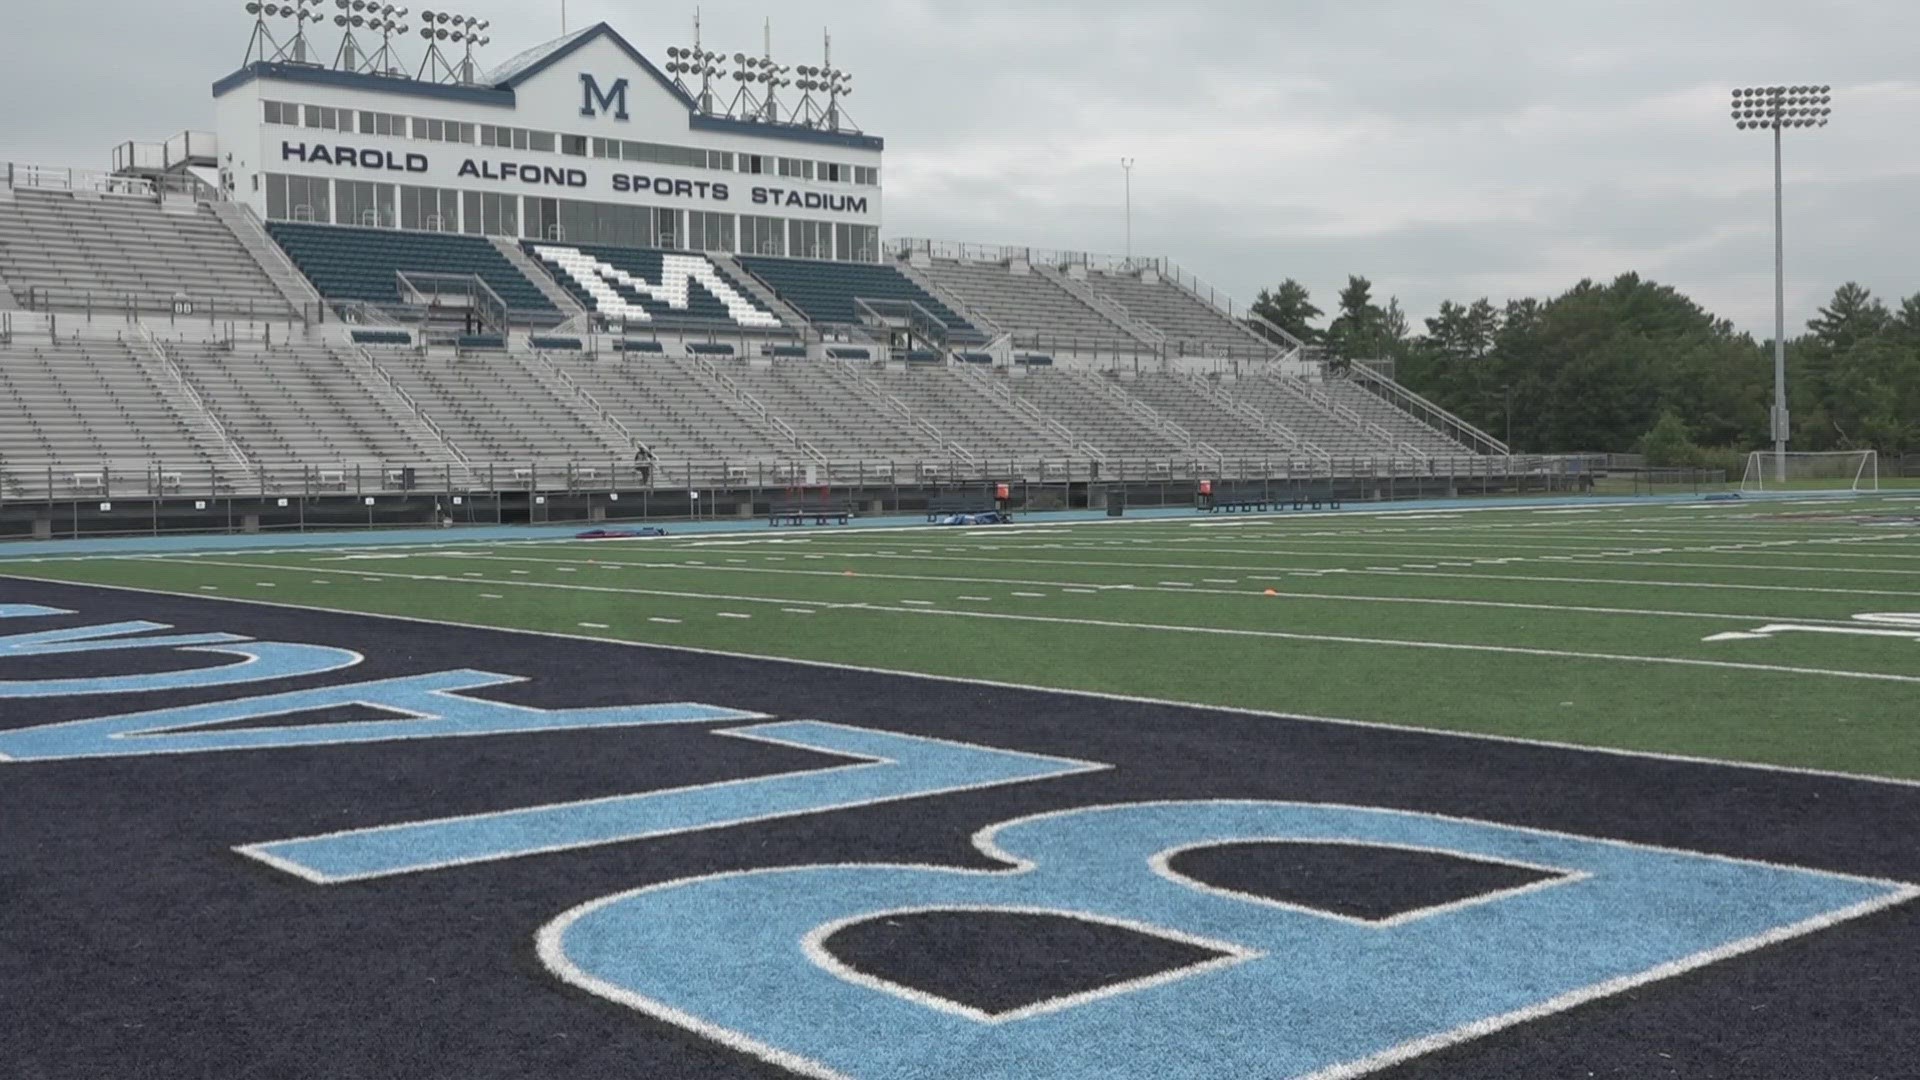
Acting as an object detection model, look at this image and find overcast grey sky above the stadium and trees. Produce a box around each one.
[0,0,1920,332]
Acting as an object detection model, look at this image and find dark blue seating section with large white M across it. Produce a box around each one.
[526,240,781,331]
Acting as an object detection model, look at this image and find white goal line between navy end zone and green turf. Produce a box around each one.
[0,568,1920,790]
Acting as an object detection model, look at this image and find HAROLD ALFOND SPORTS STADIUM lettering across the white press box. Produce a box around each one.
[280,140,870,215]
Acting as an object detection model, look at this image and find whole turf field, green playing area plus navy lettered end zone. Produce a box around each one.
[0,498,1920,1080]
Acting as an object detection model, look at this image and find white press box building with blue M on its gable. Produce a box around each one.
[210,23,885,261]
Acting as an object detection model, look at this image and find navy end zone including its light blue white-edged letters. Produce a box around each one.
[0,580,1920,1080]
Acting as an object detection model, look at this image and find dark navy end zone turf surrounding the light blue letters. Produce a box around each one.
[0,578,1920,1080]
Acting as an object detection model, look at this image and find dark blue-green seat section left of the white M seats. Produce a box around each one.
[267,221,561,321]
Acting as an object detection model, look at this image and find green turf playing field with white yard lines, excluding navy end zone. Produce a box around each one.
[0,498,1920,778]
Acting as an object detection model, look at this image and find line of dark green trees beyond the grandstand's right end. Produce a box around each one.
[1252,273,1920,465]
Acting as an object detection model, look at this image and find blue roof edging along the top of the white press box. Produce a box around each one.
[213,23,887,150]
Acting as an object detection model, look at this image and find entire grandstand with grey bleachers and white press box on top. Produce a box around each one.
[0,0,1543,536]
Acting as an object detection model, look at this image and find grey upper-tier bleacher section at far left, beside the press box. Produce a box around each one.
[0,188,292,319]
